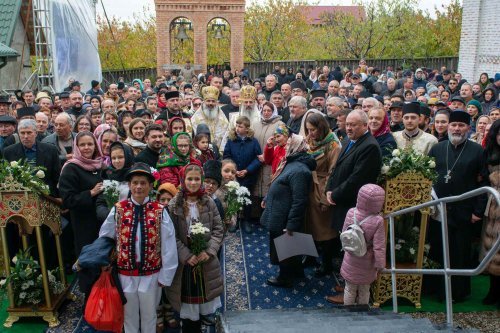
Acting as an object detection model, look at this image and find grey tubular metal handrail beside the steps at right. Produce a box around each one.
[383,186,500,326]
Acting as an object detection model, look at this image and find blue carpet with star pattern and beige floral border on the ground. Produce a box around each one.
[46,226,342,333]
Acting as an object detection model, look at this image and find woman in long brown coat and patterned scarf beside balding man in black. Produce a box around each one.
[305,113,341,277]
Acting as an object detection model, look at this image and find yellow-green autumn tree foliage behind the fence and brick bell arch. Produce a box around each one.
[98,0,462,69]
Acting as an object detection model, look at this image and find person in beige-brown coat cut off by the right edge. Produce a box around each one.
[481,120,500,306]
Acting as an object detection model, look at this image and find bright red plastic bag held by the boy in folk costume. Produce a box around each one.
[85,270,125,333]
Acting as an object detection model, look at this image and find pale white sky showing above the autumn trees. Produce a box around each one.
[97,0,460,21]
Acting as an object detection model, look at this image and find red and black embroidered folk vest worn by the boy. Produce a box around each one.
[116,200,163,276]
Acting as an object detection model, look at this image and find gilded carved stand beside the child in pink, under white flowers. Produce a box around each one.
[372,172,432,309]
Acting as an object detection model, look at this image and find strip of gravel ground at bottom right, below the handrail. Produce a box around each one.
[411,311,500,333]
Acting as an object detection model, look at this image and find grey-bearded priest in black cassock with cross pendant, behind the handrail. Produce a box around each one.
[426,111,487,302]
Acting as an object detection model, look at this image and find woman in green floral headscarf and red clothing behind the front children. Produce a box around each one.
[157,132,194,187]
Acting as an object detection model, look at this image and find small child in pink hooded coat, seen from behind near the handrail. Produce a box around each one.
[340,184,386,305]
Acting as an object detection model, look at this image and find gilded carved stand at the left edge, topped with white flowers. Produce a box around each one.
[0,179,71,327]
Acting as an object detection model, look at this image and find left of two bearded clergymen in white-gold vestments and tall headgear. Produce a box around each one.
[191,86,229,149]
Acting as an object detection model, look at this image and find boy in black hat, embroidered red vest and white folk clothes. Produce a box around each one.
[99,163,178,333]
